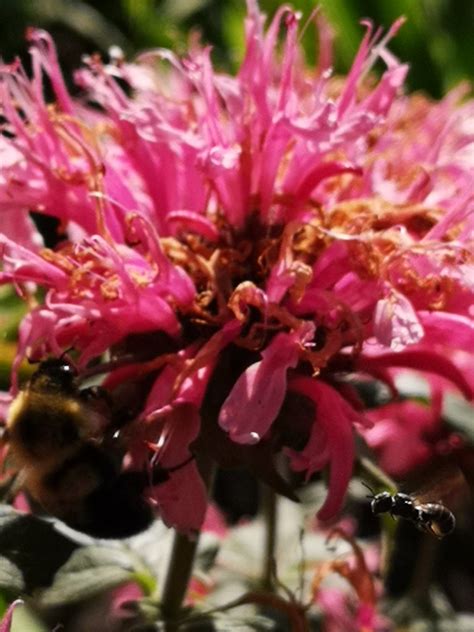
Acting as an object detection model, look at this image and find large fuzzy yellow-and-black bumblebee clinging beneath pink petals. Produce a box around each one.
[4,358,178,538]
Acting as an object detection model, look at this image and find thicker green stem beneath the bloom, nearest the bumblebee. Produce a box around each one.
[161,460,214,632]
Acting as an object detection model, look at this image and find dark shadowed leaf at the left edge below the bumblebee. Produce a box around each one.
[0,505,77,592]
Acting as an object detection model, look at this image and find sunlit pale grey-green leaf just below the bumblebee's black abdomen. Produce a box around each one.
[40,546,135,607]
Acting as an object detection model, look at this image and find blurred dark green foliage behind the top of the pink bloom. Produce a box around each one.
[0,0,474,97]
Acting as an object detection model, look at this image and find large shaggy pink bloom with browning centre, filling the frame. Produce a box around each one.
[0,0,474,530]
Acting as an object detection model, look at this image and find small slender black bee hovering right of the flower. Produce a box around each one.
[369,488,456,538]
